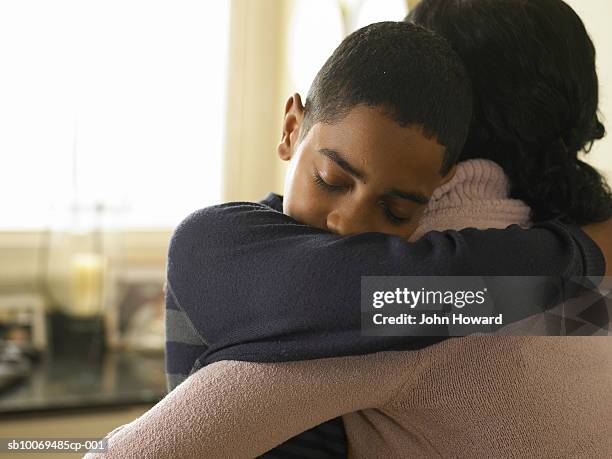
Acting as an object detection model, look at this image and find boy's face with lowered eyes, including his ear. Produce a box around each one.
[278,94,455,239]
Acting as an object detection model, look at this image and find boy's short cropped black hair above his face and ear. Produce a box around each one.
[300,22,472,175]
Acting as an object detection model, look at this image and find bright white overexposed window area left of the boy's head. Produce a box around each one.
[0,0,230,230]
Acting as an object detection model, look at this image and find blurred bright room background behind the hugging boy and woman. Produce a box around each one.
[0,0,612,457]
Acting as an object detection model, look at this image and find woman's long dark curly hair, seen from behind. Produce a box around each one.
[406,0,612,225]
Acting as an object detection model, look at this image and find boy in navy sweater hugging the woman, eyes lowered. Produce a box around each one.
[166,23,601,457]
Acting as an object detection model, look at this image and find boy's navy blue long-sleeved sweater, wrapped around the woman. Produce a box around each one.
[166,193,604,458]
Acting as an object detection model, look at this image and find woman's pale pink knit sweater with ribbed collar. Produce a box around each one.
[87,160,612,458]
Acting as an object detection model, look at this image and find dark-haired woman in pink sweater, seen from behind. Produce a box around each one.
[88,0,612,457]
